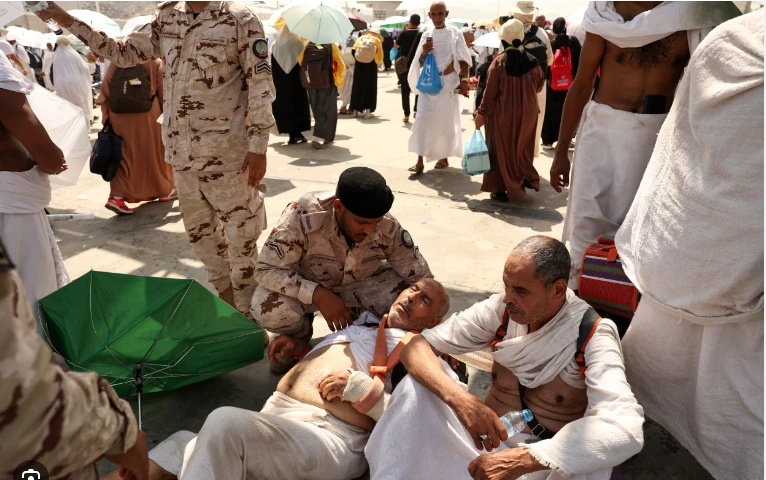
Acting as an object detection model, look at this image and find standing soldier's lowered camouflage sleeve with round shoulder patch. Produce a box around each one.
[237,15,276,154]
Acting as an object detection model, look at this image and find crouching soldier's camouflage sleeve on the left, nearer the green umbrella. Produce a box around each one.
[255,203,317,304]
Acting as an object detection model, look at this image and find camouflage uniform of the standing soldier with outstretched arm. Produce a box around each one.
[68,2,275,315]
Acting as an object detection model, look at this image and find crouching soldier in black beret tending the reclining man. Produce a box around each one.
[251,167,433,374]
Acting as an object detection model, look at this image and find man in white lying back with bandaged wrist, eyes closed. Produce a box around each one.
[126,279,449,480]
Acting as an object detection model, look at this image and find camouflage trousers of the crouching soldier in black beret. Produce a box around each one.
[250,267,410,336]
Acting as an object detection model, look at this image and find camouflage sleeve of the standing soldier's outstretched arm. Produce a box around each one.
[67,14,160,67]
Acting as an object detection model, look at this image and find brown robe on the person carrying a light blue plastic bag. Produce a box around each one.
[478,55,545,200]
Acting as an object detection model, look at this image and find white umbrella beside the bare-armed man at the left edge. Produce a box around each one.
[27,85,91,190]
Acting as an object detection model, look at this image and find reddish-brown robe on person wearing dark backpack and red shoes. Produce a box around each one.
[97,60,174,200]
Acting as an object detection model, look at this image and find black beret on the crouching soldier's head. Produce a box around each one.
[335,167,394,218]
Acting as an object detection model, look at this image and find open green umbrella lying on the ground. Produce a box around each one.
[40,271,264,428]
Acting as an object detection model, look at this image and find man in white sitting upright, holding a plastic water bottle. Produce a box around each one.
[365,236,644,480]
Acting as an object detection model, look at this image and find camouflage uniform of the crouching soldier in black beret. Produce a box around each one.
[251,192,433,336]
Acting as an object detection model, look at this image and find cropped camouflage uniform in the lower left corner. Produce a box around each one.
[0,244,137,480]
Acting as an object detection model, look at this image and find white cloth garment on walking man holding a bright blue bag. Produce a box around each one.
[407,25,472,162]
